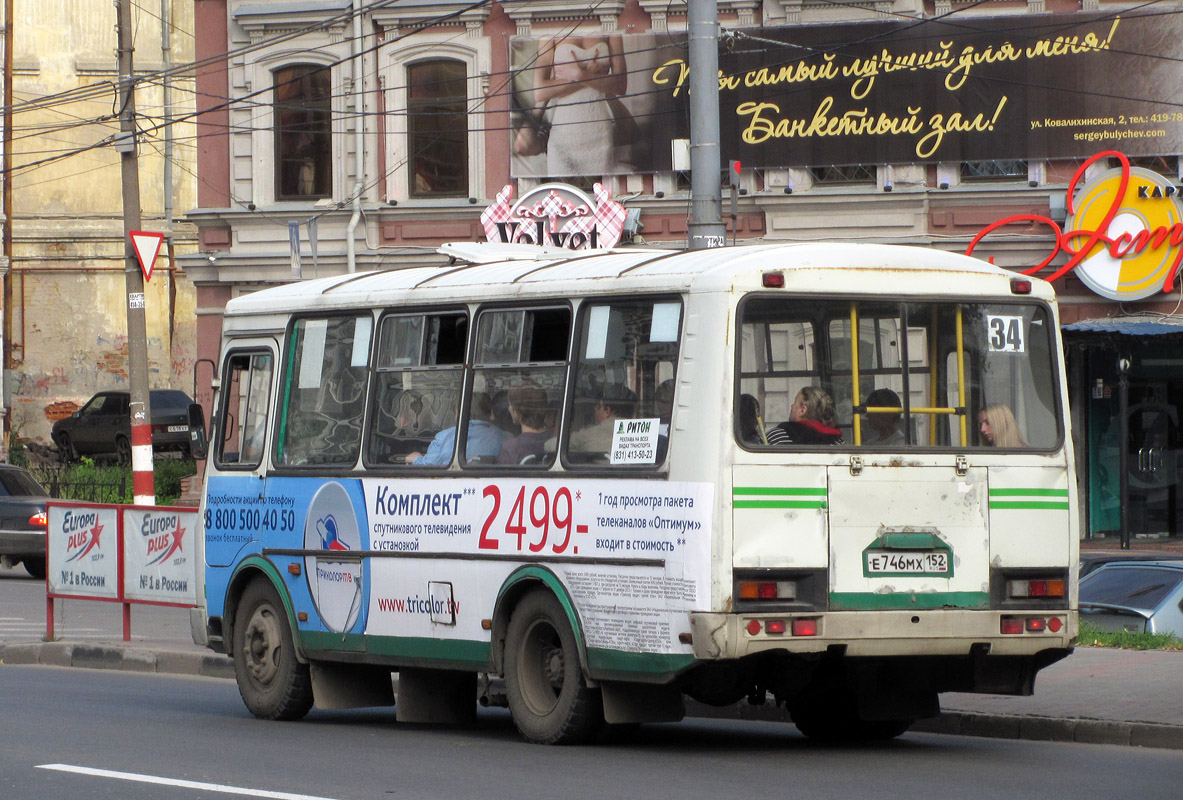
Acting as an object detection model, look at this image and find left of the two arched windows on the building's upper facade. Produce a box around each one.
[274,64,332,200]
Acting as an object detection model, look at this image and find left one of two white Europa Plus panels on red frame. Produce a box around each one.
[46,503,119,600]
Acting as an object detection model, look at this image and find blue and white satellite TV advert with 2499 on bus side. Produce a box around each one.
[205,477,713,653]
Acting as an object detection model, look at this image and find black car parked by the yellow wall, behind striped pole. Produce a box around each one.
[51,389,193,464]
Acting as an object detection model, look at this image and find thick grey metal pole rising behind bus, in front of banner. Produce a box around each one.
[686,0,728,250]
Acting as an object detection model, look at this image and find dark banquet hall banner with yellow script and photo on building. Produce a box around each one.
[508,8,1183,178]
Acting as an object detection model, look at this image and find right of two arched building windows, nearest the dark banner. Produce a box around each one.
[407,59,468,198]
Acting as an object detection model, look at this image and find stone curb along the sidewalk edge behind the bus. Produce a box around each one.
[0,641,1183,750]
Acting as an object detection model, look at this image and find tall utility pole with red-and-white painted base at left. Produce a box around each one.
[115,0,156,505]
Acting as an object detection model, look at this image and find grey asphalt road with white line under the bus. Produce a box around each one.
[0,665,1183,800]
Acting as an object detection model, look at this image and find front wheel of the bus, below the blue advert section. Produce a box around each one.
[234,579,312,720]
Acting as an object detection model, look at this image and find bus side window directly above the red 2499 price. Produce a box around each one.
[463,308,571,469]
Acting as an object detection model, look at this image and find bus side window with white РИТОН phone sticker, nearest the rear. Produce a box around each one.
[565,298,681,466]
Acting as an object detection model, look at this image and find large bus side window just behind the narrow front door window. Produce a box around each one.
[276,314,373,466]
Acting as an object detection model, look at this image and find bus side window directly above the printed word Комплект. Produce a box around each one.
[366,312,468,469]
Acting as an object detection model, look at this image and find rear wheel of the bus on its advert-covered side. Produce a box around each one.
[505,592,603,744]
